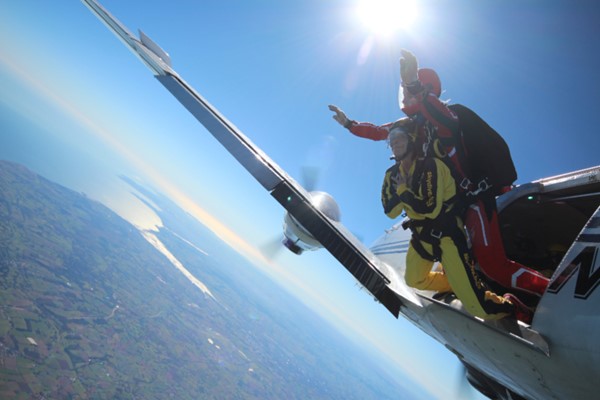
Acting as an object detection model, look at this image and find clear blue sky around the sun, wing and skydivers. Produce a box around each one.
[0,0,600,398]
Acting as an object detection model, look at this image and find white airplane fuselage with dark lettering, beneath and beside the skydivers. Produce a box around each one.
[371,212,600,399]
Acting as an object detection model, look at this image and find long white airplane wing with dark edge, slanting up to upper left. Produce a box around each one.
[82,0,422,318]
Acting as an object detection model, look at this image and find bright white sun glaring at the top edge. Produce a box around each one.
[356,0,417,37]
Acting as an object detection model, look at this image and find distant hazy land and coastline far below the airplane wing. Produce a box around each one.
[0,161,422,399]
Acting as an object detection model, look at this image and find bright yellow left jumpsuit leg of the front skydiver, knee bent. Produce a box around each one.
[404,243,452,292]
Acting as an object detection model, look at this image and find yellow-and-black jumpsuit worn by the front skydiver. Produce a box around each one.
[381,157,513,319]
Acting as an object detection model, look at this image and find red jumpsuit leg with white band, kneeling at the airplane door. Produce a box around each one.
[465,200,549,296]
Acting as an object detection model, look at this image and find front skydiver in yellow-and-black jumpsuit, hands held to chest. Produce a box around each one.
[381,118,515,319]
